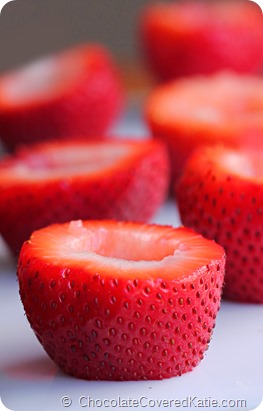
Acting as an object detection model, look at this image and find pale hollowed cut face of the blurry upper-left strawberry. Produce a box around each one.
[0,47,92,108]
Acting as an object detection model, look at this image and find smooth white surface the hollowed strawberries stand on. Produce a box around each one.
[0,112,263,411]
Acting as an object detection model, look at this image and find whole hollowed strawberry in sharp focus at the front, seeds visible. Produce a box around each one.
[18,220,225,380]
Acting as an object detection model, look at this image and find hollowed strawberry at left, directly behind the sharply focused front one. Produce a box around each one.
[0,140,169,253]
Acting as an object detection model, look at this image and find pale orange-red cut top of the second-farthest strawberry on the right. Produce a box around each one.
[147,72,263,128]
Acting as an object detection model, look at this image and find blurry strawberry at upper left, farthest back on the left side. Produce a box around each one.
[0,44,122,150]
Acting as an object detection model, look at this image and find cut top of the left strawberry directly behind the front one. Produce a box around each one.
[0,140,144,184]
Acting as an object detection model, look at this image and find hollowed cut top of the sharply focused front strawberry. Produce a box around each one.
[26,220,224,279]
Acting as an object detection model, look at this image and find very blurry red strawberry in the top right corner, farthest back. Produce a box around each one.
[139,0,263,80]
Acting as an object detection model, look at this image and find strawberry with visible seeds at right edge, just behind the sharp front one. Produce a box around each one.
[177,147,263,303]
